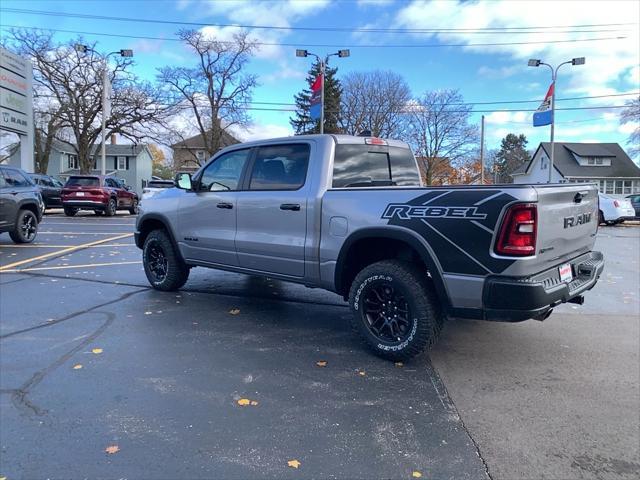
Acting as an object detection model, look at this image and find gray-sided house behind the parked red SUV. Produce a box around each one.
[8,138,153,196]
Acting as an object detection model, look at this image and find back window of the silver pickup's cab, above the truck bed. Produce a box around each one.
[332,144,420,188]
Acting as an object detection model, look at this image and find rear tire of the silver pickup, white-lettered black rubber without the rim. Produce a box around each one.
[349,260,444,362]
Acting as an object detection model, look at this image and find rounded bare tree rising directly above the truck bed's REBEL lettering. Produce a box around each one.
[406,90,479,185]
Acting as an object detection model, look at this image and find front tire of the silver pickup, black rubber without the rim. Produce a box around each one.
[142,229,189,291]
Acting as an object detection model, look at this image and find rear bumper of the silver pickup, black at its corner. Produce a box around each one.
[483,252,604,322]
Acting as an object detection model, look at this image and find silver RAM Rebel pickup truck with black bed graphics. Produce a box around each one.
[135,135,604,361]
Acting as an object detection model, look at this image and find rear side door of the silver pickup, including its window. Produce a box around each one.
[236,143,311,277]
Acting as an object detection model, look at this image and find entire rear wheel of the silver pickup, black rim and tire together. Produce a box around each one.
[349,260,444,361]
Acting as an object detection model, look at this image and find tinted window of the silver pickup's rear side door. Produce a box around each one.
[249,143,310,190]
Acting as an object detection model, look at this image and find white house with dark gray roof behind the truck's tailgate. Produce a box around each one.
[511,142,640,197]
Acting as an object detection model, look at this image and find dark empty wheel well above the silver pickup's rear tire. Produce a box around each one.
[336,237,428,296]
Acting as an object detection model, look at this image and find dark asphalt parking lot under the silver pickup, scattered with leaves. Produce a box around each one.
[0,214,640,480]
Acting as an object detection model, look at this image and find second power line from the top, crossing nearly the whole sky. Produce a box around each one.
[0,24,627,49]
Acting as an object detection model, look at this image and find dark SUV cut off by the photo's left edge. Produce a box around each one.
[0,165,44,243]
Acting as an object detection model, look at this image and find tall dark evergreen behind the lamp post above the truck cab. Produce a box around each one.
[289,61,342,135]
